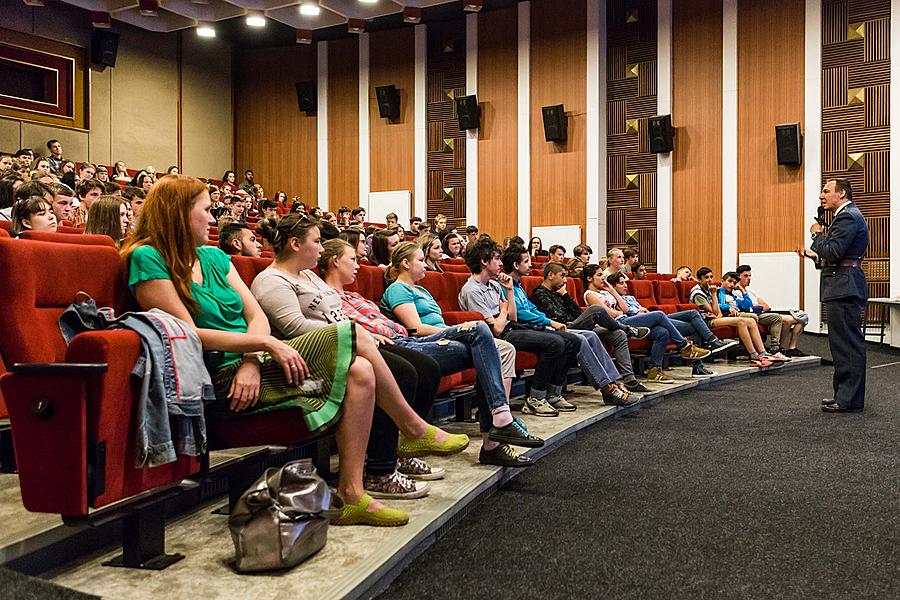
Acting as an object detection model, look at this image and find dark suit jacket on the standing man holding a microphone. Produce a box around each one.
[810,202,869,302]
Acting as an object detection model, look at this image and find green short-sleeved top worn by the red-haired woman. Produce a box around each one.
[128,246,247,369]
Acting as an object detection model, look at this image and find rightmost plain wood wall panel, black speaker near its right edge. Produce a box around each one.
[736,0,815,255]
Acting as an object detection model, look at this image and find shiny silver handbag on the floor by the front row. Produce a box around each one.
[228,458,344,573]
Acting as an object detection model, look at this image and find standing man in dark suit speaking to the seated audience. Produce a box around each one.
[809,179,869,413]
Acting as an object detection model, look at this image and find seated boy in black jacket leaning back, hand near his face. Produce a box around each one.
[531,263,650,392]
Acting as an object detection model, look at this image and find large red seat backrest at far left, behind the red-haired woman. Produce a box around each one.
[0,239,127,365]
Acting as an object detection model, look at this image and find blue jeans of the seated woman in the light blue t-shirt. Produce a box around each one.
[394,321,508,432]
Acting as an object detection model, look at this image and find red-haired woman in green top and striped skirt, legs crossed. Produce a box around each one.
[122,175,468,526]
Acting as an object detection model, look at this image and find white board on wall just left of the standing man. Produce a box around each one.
[738,252,803,311]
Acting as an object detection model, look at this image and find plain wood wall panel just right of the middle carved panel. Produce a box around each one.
[672,0,722,273]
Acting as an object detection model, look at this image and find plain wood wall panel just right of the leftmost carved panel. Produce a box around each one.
[478,6,519,240]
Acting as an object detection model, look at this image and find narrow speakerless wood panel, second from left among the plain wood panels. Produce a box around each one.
[328,36,359,209]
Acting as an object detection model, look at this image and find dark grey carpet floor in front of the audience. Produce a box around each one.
[383,336,900,600]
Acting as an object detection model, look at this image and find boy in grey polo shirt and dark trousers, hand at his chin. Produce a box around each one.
[459,237,633,417]
